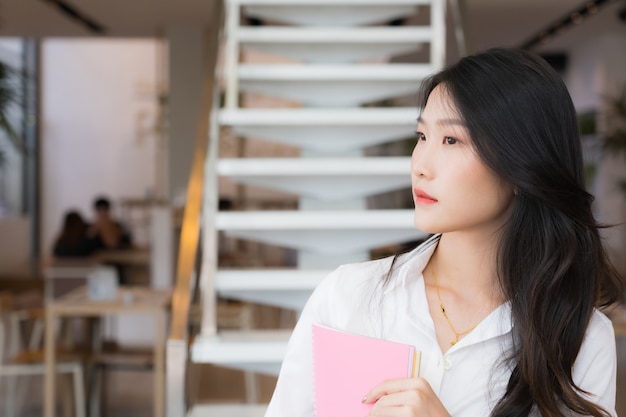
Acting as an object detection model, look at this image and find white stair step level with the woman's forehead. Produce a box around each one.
[219,107,418,153]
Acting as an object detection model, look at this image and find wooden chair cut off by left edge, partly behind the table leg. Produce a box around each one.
[0,293,85,417]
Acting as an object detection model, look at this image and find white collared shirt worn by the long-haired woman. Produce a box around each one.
[265,236,617,417]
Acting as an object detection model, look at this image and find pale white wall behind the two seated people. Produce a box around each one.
[41,39,158,254]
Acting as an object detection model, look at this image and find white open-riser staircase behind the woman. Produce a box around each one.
[189,0,445,417]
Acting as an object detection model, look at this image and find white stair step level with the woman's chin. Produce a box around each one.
[215,209,426,255]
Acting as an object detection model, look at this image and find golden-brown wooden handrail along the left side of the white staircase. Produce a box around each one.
[166,0,224,417]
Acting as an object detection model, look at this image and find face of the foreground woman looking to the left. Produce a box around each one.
[411,86,513,237]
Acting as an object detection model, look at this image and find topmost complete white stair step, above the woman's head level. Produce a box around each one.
[237,26,432,63]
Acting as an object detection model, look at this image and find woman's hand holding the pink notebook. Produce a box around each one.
[363,378,450,417]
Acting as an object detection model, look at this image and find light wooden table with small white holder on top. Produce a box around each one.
[44,287,172,417]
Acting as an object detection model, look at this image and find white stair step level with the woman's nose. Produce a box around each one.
[217,157,411,200]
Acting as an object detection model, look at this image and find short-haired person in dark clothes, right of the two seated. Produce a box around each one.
[87,197,132,250]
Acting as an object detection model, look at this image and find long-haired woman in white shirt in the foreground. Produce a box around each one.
[267,49,622,417]
